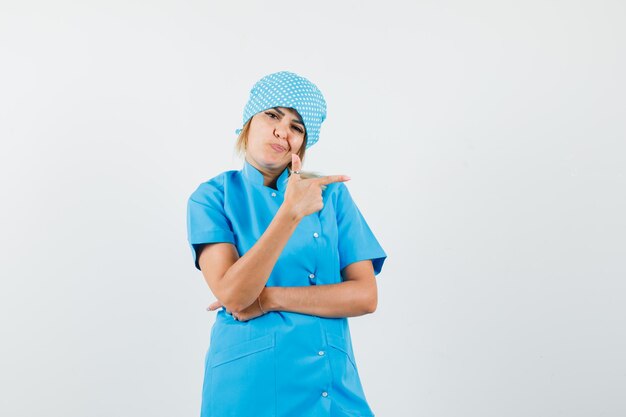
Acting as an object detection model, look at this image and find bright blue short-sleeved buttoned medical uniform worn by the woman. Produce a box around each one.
[187,161,387,417]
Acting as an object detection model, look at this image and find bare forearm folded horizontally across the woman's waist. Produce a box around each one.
[261,281,376,318]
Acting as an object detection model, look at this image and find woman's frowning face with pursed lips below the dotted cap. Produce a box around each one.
[246,107,305,174]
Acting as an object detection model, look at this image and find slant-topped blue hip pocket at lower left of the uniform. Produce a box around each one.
[205,334,276,417]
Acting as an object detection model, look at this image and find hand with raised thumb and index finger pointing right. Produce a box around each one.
[283,153,350,220]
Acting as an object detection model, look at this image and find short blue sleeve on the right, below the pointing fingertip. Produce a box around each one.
[336,183,387,275]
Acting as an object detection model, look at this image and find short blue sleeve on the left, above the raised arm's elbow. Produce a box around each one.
[187,180,235,269]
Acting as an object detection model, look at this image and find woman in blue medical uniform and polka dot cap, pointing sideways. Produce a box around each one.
[187,71,387,417]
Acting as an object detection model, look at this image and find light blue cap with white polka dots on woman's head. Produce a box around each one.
[235,71,326,149]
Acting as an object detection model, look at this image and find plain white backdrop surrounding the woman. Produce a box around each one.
[0,0,626,417]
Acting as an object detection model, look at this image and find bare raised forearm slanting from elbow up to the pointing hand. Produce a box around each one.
[221,206,300,312]
